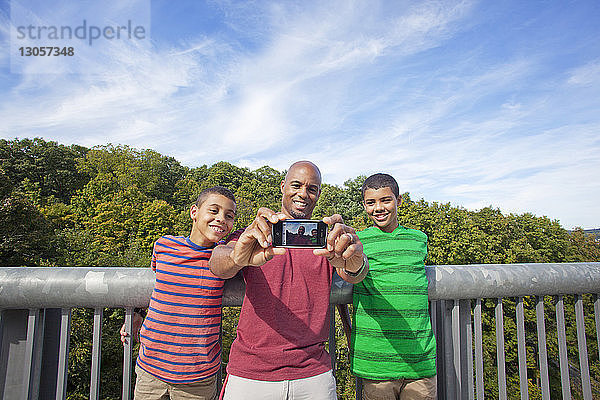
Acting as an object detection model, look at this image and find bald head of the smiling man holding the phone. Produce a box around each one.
[281,163,321,218]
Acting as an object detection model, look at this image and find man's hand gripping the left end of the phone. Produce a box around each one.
[230,207,287,266]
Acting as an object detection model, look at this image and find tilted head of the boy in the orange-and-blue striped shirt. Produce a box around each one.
[190,193,235,247]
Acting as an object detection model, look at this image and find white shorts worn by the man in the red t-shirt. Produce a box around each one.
[223,371,337,400]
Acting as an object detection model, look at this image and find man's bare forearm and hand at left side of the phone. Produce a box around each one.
[208,207,286,279]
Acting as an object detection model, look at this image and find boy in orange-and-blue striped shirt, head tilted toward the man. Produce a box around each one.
[121,186,236,400]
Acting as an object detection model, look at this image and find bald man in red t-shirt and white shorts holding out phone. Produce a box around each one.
[209,161,368,400]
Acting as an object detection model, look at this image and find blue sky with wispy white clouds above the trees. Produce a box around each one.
[0,0,600,229]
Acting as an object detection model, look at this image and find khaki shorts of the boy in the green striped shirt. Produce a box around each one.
[362,376,437,400]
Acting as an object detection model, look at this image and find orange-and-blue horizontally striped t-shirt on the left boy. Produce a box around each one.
[137,236,225,383]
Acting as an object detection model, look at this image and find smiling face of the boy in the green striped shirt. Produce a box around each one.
[363,187,402,232]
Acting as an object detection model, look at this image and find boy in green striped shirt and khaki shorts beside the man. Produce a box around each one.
[350,174,437,400]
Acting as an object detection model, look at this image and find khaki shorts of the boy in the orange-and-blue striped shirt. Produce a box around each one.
[133,365,217,400]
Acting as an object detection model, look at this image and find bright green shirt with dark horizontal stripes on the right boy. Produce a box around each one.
[350,226,436,380]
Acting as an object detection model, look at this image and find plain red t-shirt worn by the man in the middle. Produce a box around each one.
[227,242,333,381]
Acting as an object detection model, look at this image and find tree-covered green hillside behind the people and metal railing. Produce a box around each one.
[0,138,600,399]
